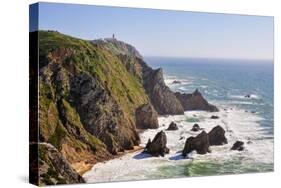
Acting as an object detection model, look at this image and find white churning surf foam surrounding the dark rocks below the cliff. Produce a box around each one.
[83,106,273,182]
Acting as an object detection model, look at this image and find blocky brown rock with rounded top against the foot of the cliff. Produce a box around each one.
[136,103,159,129]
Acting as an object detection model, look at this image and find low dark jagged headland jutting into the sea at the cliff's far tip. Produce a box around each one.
[175,89,219,112]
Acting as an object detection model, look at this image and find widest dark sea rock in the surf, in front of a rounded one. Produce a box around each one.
[182,131,209,157]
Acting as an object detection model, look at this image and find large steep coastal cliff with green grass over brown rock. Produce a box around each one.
[30,31,216,185]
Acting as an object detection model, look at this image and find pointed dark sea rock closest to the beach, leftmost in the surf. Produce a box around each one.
[144,131,170,157]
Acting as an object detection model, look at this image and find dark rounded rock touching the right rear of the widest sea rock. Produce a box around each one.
[208,125,227,146]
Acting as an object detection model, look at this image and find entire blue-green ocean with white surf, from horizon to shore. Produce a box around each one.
[83,57,274,183]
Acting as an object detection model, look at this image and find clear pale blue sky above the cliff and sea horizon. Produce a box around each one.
[30,3,274,60]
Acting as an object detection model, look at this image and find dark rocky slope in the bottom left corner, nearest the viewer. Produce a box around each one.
[33,143,85,186]
